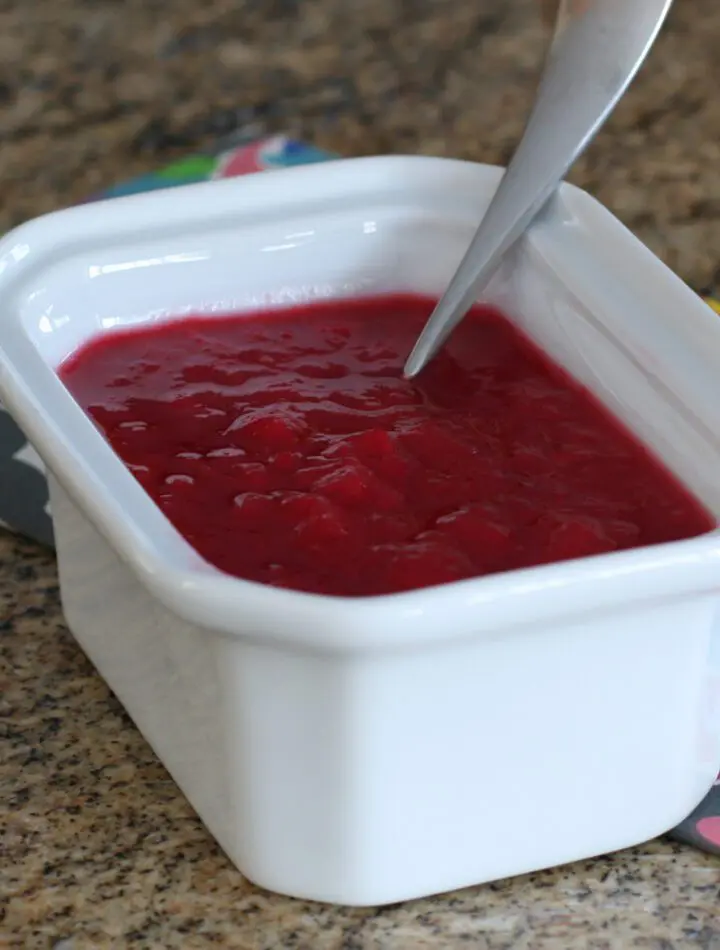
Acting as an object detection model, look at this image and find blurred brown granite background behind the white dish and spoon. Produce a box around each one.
[0,0,720,287]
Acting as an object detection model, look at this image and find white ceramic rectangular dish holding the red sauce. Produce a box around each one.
[0,158,720,904]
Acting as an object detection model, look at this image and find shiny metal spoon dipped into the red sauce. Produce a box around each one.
[405,0,672,378]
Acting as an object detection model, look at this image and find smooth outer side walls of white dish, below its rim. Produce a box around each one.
[51,470,720,905]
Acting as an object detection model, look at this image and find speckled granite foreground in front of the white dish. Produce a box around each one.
[0,533,720,950]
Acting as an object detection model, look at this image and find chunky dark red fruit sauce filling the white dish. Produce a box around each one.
[61,296,714,595]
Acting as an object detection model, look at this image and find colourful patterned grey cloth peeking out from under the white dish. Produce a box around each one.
[0,135,720,855]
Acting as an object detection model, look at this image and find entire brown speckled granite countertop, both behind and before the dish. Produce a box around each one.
[0,0,720,950]
